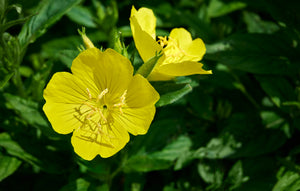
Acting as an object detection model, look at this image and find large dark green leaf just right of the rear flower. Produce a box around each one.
[205,33,300,75]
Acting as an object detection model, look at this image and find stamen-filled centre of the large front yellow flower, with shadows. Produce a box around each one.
[75,88,127,147]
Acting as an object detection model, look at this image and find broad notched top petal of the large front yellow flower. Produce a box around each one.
[71,48,133,94]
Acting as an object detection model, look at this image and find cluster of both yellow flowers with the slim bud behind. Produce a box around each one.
[43,7,211,160]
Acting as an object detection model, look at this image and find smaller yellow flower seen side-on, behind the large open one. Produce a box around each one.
[130,7,212,81]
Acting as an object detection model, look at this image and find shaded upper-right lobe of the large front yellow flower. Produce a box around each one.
[126,74,159,108]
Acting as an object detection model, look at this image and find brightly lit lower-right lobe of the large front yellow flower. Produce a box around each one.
[113,105,155,135]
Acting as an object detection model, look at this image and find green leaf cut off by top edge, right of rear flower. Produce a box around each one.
[207,0,246,18]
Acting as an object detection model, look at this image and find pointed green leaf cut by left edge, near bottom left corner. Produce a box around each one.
[0,155,22,182]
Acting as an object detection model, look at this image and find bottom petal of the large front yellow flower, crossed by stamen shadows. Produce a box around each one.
[71,123,129,160]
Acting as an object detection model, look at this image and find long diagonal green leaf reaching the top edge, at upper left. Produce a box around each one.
[19,0,81,47]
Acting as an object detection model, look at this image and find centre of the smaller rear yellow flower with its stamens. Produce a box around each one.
[157,36,186,64]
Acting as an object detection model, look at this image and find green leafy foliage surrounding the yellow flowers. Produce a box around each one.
[0,0,300,191]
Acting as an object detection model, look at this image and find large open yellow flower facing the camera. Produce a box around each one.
[43,48,159,160]
